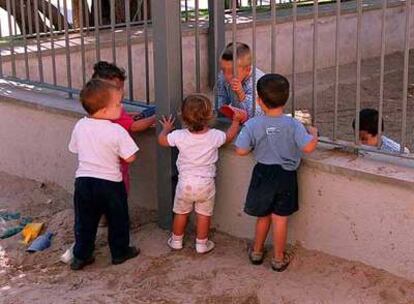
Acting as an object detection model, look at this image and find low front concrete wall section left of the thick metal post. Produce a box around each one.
[0,89,157,217]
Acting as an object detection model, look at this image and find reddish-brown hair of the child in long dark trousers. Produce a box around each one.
[80,79,119,115]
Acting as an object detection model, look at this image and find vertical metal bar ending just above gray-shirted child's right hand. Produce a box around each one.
[312,0,319,124]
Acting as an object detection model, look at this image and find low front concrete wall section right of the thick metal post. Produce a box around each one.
[214,148,414,279]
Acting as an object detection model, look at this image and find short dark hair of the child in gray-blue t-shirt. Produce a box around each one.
[257,74,289,109]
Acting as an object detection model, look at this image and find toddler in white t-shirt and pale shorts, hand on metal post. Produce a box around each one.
[158,94,243,253]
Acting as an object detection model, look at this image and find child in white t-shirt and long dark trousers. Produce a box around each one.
[69,79,139,270]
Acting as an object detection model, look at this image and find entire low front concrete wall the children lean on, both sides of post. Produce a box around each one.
[0,88,414,280]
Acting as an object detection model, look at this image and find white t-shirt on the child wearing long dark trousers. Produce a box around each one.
[69,117,139,182]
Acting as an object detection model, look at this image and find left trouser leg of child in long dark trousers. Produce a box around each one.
[73,177,102,261]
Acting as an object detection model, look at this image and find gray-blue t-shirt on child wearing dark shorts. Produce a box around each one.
[236,115,313,171]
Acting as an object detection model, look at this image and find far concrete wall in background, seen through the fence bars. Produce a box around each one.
[3,3,414,100]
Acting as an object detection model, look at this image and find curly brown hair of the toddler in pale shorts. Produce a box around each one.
[181,94,213,132]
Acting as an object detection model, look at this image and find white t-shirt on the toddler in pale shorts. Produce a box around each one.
[167,129,226,178]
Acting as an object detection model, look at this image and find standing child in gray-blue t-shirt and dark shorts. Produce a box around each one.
[236,74,318,271]
